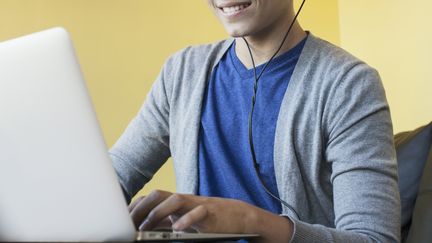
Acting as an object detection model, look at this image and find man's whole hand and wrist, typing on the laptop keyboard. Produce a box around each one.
[129,191,293,242]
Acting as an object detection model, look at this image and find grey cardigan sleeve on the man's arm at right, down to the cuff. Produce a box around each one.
[286,63,400,242]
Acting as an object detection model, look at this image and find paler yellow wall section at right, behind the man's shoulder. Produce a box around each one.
[339,0,432,132]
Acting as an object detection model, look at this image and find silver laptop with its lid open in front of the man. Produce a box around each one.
[0,28,257,242]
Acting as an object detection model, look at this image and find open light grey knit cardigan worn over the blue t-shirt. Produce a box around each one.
[110,34,400,242]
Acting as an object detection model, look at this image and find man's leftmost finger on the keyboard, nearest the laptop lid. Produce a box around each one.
[130,190,172,227]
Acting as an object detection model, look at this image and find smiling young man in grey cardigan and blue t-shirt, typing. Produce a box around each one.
[110,0,400,242]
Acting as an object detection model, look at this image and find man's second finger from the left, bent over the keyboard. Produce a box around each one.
[139,194,195,231]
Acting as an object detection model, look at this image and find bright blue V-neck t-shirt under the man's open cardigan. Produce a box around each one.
[198,39,306,214]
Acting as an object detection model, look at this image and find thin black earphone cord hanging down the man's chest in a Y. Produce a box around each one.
[242,0,306,219]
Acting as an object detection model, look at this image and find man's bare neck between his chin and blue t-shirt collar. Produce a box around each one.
[235,22,306,69]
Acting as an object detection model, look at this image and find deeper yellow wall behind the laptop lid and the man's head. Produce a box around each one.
[0,0,339,197]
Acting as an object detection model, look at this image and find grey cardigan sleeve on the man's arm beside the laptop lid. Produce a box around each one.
[109,58,174,200]
